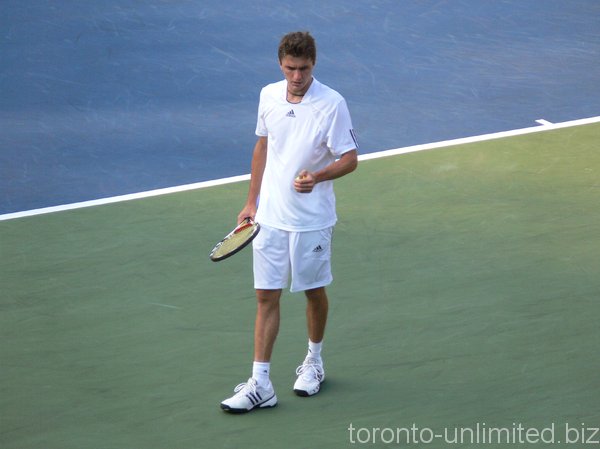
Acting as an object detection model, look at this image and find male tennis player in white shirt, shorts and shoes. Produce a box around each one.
[221,32,358,413]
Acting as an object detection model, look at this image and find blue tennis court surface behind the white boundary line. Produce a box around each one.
[0,0,600,214]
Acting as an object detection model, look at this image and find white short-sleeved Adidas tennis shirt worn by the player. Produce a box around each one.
[256,78,358,231]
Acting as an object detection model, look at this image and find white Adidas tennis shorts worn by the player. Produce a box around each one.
[252,225,333,292]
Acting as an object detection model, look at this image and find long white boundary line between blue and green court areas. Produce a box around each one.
[0,116,600,221]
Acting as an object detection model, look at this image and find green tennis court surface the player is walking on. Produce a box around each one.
[0,125,600,449]
